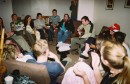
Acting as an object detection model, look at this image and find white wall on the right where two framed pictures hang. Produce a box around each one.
[94,0,130,44]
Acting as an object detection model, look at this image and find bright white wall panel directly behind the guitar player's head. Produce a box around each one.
[78,0,94,22]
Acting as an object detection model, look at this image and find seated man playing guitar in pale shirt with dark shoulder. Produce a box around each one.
[71,16,95,51]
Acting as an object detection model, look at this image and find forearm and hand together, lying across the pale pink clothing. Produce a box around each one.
[73,67,90,84]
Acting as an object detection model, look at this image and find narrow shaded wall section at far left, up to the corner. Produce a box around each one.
[0,0,12,31]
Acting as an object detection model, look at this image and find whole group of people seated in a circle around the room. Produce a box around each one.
[0,9,130,84]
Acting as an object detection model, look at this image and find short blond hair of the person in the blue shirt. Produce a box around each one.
[33,39,48,57]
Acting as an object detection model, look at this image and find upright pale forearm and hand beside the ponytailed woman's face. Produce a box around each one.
[91,52,103,84]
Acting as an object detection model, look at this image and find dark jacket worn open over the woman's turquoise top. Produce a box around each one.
[58,19,75,33]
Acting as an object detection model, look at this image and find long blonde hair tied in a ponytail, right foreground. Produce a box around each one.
[101,41,130,84]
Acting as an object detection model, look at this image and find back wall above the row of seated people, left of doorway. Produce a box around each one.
[12,0,71,18]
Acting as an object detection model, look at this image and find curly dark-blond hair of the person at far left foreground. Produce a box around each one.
[2,44,16,60]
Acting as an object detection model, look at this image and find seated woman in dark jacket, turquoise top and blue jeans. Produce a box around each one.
[58,14,74,43]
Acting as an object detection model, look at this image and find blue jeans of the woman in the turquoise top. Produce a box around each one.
[58,30,71,43]
